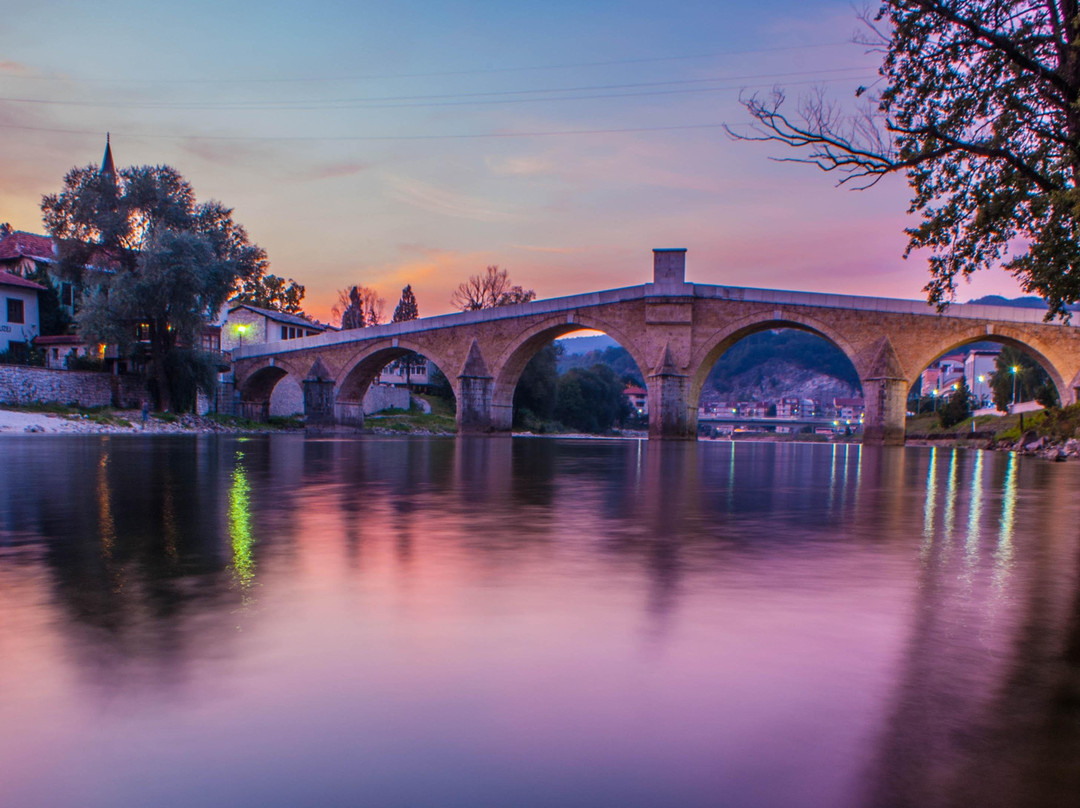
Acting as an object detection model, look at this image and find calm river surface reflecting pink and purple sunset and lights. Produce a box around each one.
[0,436,1080,807]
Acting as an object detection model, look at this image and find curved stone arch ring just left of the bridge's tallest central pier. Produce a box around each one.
[490,311,649,431]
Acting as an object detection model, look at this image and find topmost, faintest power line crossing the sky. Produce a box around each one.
[3,40,851,84]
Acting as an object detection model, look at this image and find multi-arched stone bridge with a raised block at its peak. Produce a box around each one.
[233,250,1080,444]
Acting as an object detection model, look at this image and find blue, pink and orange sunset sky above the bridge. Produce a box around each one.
[0,0,1021,321]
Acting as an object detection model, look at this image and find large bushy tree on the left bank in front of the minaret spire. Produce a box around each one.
[41,165,267,410]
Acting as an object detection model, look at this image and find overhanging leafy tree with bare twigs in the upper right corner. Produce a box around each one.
[729,0,1080,320]
